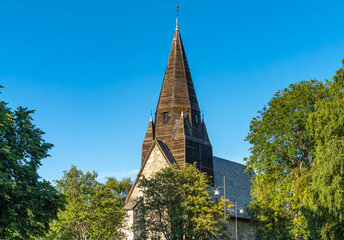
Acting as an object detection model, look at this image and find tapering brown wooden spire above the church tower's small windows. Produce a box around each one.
[157,26,199,111]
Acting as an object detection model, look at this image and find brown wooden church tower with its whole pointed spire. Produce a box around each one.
[141,12,213,178]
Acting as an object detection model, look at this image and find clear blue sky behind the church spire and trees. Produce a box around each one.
[0,0,344,180]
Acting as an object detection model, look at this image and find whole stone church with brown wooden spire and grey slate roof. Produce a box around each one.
[124,6,256,240]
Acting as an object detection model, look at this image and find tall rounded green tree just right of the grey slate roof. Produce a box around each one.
[246,80,329,239]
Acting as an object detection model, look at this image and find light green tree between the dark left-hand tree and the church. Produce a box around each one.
[47,166,131,240]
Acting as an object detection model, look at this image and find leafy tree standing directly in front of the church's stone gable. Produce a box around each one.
[134,164,231,240]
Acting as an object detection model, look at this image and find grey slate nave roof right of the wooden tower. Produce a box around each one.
[213,156,252,219]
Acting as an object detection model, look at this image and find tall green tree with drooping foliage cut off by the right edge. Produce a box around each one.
[303,61,344,240]
